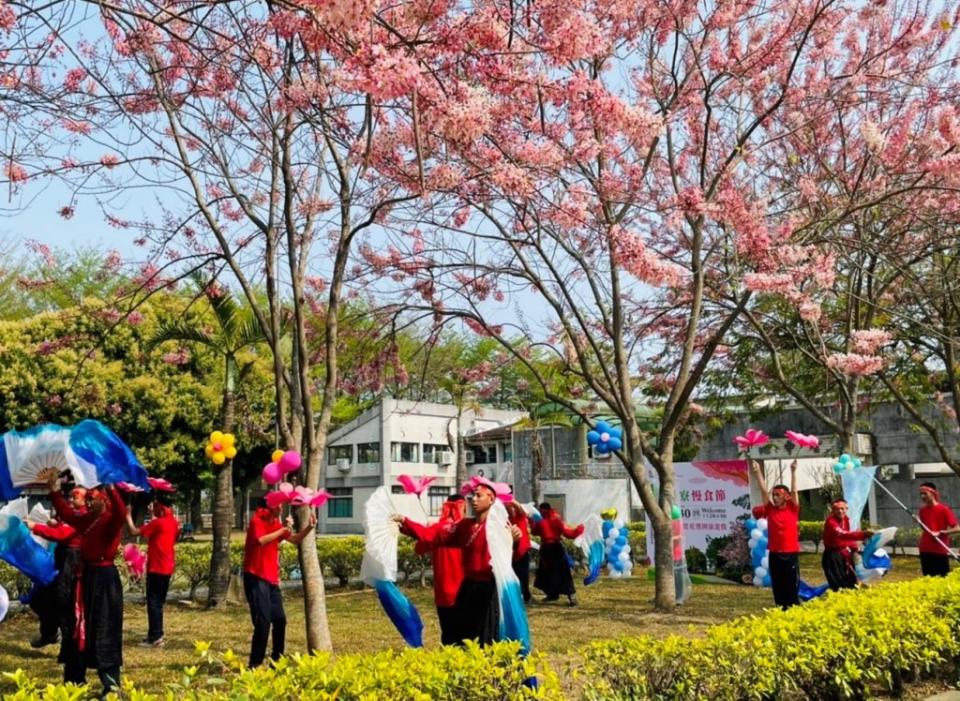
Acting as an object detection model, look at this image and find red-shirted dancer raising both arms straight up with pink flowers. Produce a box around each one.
[750,460,800,609]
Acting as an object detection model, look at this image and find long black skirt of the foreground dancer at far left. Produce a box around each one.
[82,565,123,669]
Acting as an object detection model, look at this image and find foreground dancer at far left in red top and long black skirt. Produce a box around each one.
[47,471,127,695]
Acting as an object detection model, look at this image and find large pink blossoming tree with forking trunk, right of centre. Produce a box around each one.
[352,0,952,610]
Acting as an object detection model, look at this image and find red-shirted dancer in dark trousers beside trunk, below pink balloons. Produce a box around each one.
[243,499,317,667]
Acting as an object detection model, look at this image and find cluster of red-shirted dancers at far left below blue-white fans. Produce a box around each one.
[26,469,180,694]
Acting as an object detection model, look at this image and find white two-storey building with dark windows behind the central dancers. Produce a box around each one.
[319,398,524,533]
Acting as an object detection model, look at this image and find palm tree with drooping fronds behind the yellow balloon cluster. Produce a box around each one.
[148,279,266,608]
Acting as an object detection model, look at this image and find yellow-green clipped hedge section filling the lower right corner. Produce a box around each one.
[578,575,960,701]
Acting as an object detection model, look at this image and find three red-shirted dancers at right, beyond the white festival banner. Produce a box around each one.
[750,460,960,609]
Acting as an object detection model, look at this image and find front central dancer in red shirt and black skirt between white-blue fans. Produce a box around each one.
[395,483,520,646]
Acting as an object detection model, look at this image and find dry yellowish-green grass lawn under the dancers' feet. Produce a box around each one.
[0,554,920,693]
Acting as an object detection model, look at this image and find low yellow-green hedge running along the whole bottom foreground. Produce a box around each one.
[4,574,960,701]
